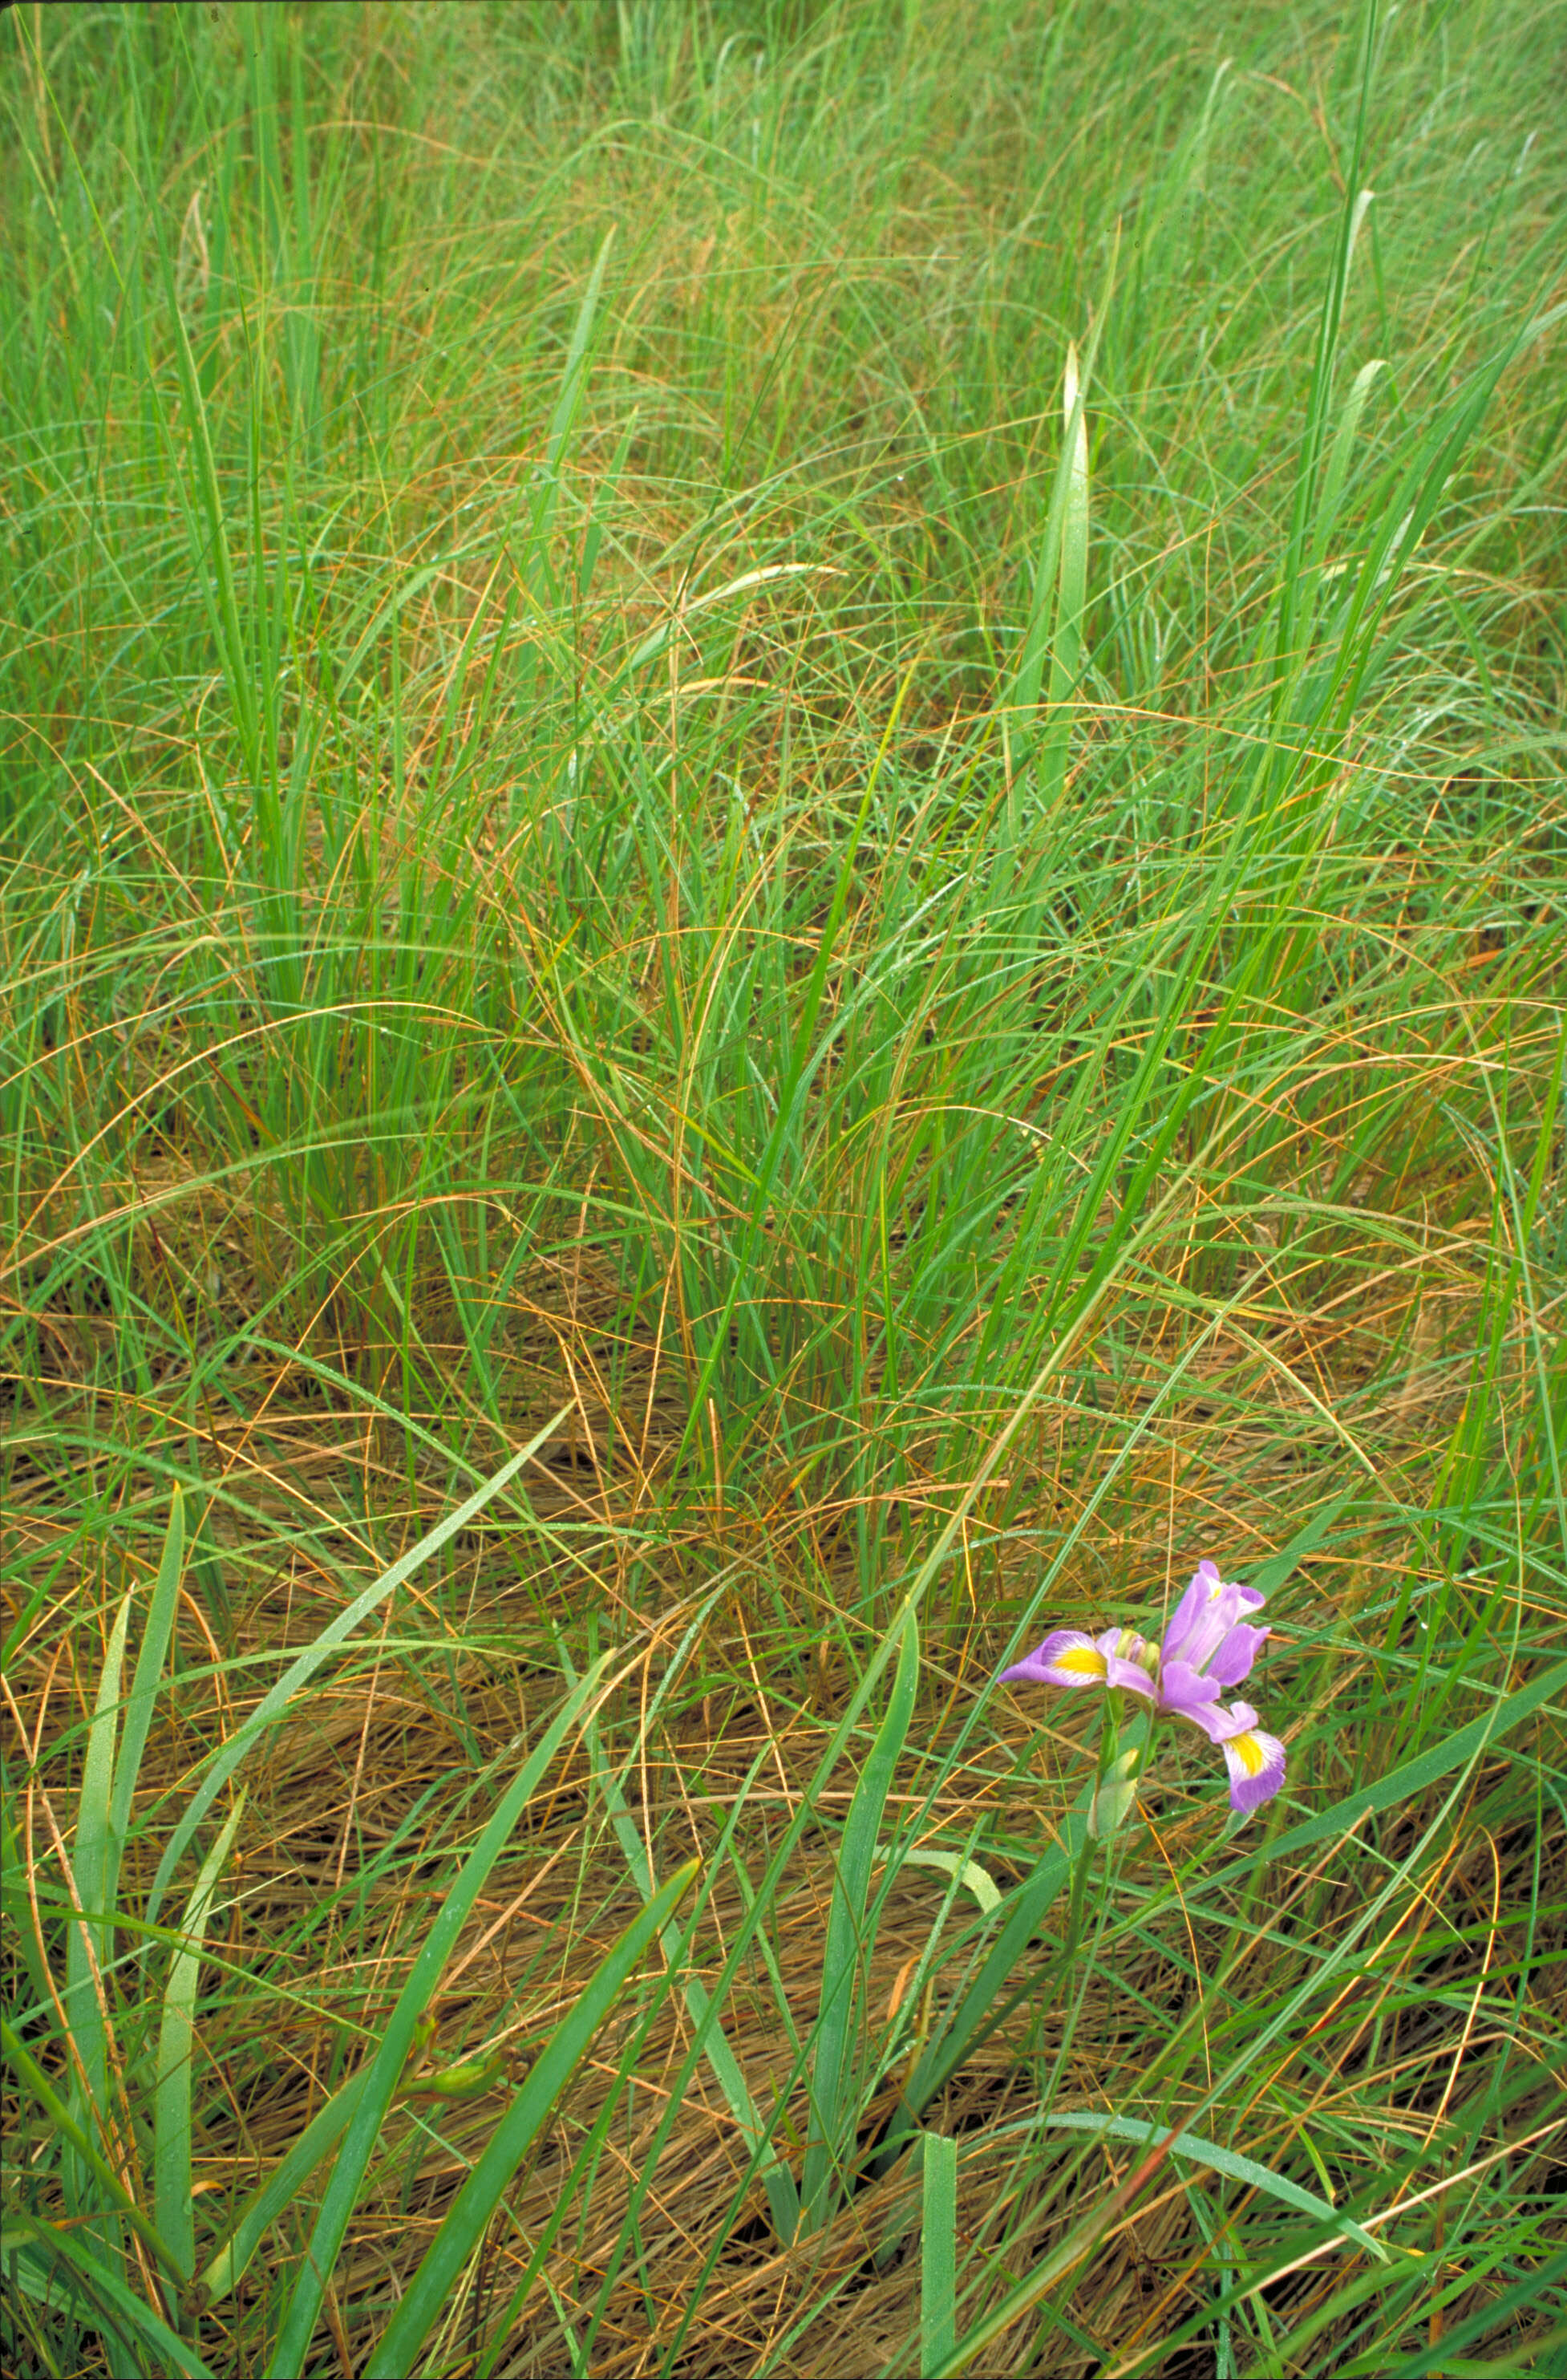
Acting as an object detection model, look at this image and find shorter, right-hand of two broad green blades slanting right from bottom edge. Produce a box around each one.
[371,1859,702,2373]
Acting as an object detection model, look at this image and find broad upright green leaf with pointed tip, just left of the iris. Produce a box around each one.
[799,1612,920,2232]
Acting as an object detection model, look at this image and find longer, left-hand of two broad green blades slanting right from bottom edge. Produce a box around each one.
[266,1652,613,2380]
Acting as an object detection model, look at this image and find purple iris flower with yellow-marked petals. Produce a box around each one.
[1001,1561,1284,1814]
